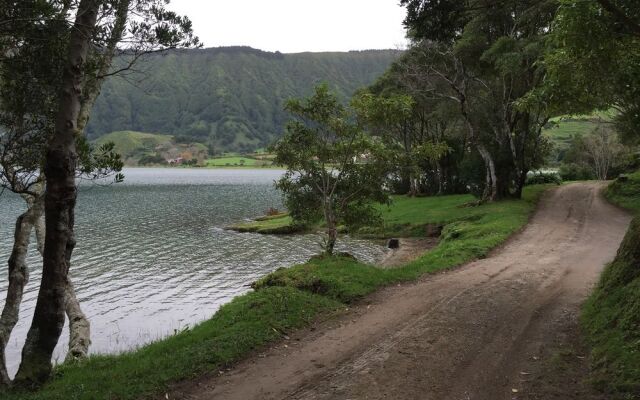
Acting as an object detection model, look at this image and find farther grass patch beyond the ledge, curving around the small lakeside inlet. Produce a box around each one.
[254,186,548,301]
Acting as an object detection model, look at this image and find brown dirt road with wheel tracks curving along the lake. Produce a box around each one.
[173,183,630,400]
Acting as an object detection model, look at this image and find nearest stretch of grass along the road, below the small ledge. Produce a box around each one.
[5,287,342,400]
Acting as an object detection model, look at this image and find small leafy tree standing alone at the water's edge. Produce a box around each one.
[270,85,389,255]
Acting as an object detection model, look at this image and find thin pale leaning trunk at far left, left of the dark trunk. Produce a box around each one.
[0,196,44,387]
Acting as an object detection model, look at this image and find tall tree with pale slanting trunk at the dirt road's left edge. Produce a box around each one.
[401,0,557,200]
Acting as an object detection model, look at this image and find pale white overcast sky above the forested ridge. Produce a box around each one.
[169,0,406,53]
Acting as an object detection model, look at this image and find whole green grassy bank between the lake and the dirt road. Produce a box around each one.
[0,186,546,400]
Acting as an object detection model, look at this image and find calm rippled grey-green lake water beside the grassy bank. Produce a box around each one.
[0,168,386,372]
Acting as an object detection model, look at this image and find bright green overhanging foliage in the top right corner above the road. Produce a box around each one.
[534,0,640,140]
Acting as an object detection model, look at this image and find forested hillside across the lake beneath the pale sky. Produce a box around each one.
[87,47,400,153]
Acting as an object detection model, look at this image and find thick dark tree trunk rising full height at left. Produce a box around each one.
[16,0,100,386]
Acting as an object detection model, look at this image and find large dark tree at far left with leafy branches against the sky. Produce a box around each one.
[0,0,197,385]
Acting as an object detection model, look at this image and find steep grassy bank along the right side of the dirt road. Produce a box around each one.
[581,172,640,399]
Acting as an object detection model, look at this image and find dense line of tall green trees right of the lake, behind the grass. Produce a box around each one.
[350,0,640,201]
